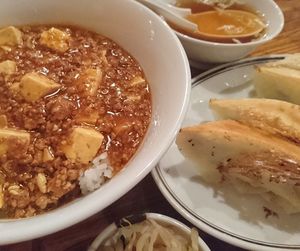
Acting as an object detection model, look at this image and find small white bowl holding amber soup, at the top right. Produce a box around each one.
[171,0,284,64]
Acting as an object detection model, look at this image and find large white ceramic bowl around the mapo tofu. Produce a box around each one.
[0,0,190,245]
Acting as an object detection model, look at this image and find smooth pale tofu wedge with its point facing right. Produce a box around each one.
[19,72,60,102]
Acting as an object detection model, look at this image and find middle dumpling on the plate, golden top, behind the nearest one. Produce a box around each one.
[209,98,300,144]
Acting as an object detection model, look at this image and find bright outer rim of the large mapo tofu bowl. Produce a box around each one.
[0,0,191,245]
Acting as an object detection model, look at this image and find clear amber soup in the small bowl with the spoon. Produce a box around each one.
[172,1,265,43]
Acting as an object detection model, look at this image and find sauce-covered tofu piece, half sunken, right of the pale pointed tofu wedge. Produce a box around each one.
[78,68,102,96]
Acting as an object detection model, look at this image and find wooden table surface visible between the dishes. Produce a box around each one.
[0,0,300,251]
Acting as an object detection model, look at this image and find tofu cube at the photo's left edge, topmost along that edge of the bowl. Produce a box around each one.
[0,26,23,46]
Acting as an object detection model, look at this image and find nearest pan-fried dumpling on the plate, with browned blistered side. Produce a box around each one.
[176,120,300,213]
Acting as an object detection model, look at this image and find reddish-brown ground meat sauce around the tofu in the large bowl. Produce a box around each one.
[0,25,151,218]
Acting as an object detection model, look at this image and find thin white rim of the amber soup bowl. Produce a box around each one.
[173,0,284,48]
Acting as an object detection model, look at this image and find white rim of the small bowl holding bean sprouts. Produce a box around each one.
[87,213,210,251]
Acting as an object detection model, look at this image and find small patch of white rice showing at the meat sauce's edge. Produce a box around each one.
[79,152,112,194]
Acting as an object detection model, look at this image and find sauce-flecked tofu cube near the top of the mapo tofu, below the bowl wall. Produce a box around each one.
[40,27,70,52]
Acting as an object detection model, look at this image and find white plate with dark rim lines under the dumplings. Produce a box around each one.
[152,56,300,251]
